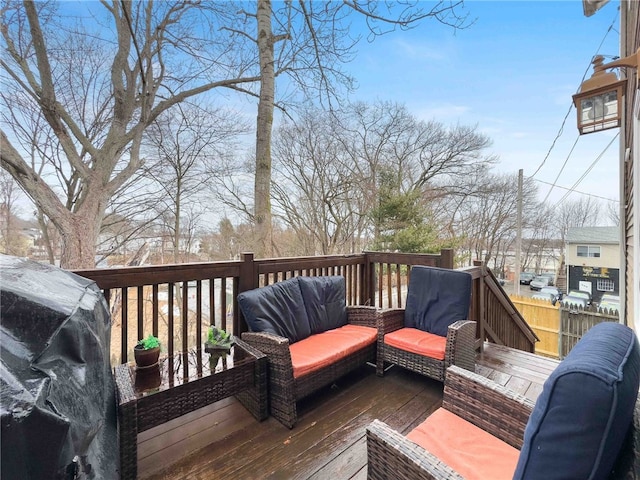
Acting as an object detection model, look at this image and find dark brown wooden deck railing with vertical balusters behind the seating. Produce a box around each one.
[76,250,535,364]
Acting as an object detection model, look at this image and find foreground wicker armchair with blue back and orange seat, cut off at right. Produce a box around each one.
[366,323,640,480]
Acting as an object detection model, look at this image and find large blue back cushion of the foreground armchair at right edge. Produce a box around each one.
[513,323,640,479]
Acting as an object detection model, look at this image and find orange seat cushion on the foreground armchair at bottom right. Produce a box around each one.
[407,408,520,480]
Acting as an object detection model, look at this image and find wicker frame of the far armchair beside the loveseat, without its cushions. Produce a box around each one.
[376,308,476,382]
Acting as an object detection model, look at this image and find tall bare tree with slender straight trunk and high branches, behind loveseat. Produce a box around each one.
[225,0,466,256]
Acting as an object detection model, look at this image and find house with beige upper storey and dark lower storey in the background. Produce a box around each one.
[565,227,620,302]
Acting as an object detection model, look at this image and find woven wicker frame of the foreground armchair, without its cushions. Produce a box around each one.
[366,366,640,480]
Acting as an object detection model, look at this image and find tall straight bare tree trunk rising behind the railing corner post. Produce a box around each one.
[254,0,275,258]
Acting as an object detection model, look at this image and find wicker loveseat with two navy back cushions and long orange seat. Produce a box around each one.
[238,276,378,428]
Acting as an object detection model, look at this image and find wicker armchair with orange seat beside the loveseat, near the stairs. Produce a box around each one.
[376,266,476,381]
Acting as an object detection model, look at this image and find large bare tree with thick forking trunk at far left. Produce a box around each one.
[0,0,258,268]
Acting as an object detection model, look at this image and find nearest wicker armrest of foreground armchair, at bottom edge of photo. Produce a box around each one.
[366,420,463,480]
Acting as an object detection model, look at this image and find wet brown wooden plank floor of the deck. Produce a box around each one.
[139,345,557,480]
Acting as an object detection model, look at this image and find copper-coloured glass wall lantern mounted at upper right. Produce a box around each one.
[573,49,640,135]
